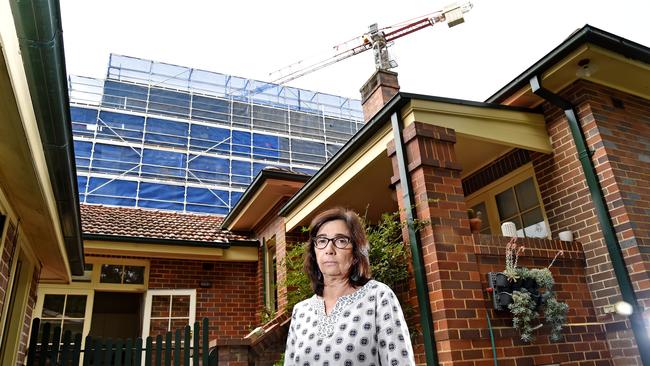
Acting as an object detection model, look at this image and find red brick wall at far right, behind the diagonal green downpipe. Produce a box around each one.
[533,81,650,365]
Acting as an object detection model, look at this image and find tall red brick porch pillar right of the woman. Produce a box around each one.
[388,122,491,365]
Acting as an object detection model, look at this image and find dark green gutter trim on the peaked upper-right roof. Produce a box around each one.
[486,24,650,103]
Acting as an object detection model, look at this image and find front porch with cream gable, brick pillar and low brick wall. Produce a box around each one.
[233,94,609,364]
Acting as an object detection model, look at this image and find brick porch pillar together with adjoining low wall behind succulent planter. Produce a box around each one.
[389,122,610,366]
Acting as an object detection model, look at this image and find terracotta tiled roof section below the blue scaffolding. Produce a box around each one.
[81,204,250,244]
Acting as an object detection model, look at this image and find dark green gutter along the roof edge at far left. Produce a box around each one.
[10,0,84,275]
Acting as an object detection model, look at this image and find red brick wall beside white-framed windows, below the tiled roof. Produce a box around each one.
[149,259,259,341]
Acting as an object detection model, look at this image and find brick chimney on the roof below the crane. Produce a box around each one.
[359,70,399,122]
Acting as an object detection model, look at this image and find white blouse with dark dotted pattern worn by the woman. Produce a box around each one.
[284,280,415,366]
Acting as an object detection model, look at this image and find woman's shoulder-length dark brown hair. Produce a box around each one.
[304,207,371,296]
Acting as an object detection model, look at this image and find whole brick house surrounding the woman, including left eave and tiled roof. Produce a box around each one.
[0,2,650,365]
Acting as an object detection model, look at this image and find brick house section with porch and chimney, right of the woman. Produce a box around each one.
[223,25,650,365]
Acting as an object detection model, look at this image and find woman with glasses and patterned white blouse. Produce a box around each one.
[284,208,415,366]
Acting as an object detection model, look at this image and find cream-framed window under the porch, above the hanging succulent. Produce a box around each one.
[466,163,549,238]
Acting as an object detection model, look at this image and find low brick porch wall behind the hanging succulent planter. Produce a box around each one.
[474,235,611,366]
